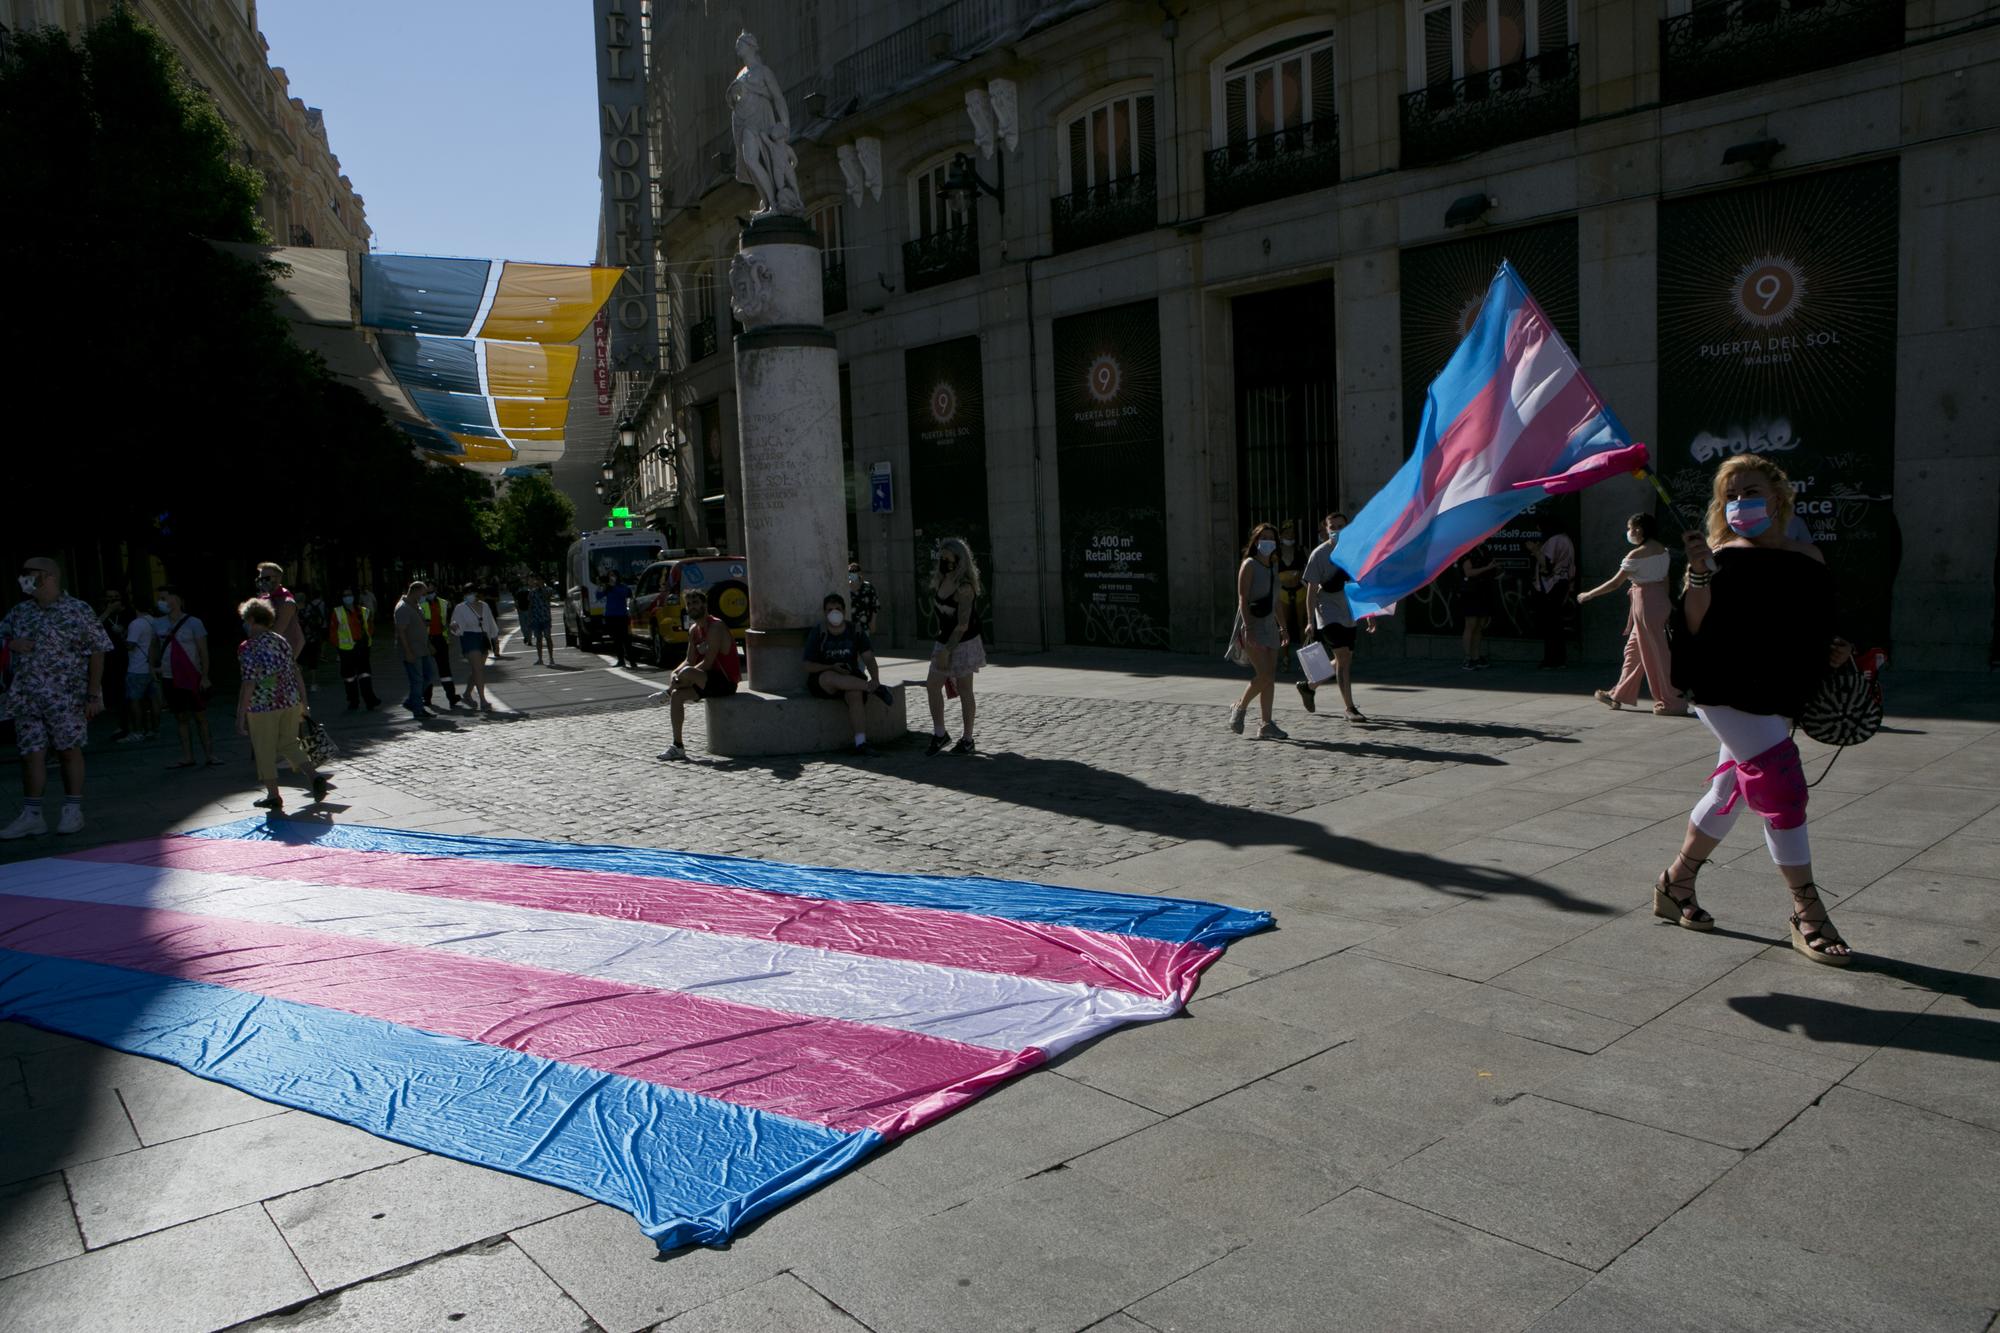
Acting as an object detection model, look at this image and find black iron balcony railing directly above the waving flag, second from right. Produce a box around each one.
[1402,46,1578,166]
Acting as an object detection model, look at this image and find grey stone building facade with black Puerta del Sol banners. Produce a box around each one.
[604,0,2000,669]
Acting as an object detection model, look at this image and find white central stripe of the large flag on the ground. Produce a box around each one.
[0,861,1180,1053]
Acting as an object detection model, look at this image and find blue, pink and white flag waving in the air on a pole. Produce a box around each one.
[1334,264,1644,616]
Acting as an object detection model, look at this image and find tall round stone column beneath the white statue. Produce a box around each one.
[730,214,848,695]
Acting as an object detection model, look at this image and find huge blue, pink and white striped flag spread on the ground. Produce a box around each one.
[0,821,1270,1249]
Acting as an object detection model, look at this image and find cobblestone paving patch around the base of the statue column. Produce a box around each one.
[348,695,1566,879]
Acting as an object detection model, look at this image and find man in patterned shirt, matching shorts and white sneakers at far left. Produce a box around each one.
[0,556,112,839]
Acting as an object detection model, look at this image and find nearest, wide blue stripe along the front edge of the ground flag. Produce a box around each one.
[0,949,882,1249]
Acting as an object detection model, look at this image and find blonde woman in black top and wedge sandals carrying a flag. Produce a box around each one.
[1652,454,1854,967]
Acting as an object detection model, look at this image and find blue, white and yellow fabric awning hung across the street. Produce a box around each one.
[224,244,618,472]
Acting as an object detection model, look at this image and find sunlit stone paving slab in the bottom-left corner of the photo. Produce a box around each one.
[0,1207,314,1333]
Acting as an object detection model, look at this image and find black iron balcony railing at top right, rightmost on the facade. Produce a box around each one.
[1660,0,1904,102]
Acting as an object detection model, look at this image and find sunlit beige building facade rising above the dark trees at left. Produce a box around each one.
[16,0,368,250]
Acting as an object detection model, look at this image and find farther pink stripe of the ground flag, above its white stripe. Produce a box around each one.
[66,837,1222,1003]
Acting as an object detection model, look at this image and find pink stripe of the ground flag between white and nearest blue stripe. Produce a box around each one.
[0,897,1044,1137]
